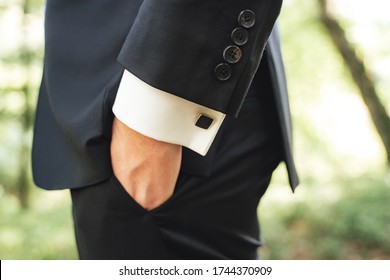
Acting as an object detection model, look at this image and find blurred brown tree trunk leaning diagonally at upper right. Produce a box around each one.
[318,0,390,164]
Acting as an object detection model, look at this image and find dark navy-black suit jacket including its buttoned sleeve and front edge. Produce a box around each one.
[33,0,298,189]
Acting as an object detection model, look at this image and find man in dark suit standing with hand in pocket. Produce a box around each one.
[33,0,298,259]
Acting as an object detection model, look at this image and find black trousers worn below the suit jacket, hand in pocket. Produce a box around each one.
[71,71,282,259]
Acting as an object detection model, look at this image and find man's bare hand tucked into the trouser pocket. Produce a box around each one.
[111,118,182,210]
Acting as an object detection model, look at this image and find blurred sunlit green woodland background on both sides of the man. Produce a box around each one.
[0,0,390,259]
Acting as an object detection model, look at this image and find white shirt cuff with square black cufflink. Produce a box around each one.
[112,70,225,156]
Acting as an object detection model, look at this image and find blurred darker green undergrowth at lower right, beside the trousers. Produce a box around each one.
[260,172,390,260]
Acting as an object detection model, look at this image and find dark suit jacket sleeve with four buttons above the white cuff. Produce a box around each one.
[118,0,282,115]
